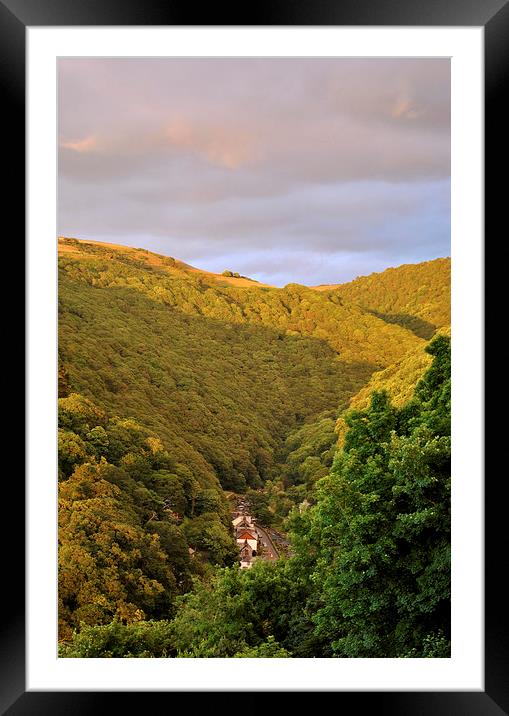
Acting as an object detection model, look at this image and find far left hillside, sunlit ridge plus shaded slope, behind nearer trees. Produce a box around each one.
[59,242,422,490]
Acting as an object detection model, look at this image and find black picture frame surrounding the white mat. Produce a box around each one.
[8,0,500,716]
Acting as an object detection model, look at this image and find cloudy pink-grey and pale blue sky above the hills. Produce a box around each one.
[58,58,450,286]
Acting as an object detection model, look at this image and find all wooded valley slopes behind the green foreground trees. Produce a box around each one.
[59,238,449,637]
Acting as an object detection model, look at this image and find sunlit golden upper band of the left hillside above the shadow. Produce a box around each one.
[60,240,416,368]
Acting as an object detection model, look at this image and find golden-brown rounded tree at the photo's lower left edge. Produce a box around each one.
[59,460,176,635]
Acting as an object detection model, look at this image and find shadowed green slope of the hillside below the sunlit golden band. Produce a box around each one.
[60,260,370,492]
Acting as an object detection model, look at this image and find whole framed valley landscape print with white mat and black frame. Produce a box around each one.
[9,0,498,715]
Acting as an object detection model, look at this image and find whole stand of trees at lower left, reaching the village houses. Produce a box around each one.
[59,393,236,638]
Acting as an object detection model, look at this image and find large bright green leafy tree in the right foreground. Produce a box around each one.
[288,337,450,657]
